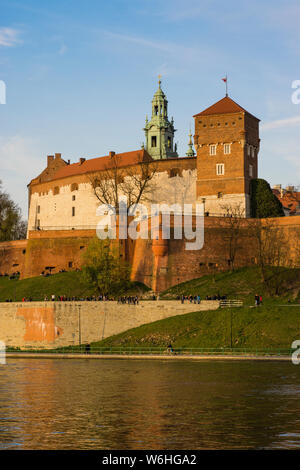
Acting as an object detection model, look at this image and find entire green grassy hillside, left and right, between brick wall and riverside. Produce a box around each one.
[0,268,300,348]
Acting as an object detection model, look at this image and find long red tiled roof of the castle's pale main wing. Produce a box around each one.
[53,149,152,179]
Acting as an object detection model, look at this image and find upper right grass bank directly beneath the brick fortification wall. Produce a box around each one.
[161,267,300,303]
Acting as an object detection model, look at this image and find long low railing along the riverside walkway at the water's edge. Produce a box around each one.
[6,344,294,357]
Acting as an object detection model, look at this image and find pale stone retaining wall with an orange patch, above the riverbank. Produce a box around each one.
[0,301,219,349]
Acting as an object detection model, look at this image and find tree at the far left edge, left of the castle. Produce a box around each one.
[0,181,27,241]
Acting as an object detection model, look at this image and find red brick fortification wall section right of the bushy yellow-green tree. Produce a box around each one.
[132,216,300,292]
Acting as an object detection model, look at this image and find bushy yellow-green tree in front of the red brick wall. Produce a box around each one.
[82,238,130,294]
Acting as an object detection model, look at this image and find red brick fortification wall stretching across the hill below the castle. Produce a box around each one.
[0,216,300,291]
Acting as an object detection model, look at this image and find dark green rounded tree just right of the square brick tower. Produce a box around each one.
[251,178,284,219]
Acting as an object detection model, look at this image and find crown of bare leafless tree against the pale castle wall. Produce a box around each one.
[90,155,157,213]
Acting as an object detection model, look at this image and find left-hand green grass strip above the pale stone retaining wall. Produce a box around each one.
[0,271,148,302]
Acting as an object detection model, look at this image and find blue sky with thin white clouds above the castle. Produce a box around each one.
[0,0,300,218]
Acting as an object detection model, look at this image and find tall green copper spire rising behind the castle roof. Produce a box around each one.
[144,77,178,160]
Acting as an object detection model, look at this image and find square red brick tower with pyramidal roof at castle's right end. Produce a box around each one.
[194,95,260,217]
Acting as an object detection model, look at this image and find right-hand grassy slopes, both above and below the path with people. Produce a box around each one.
[85,267,300,348]
